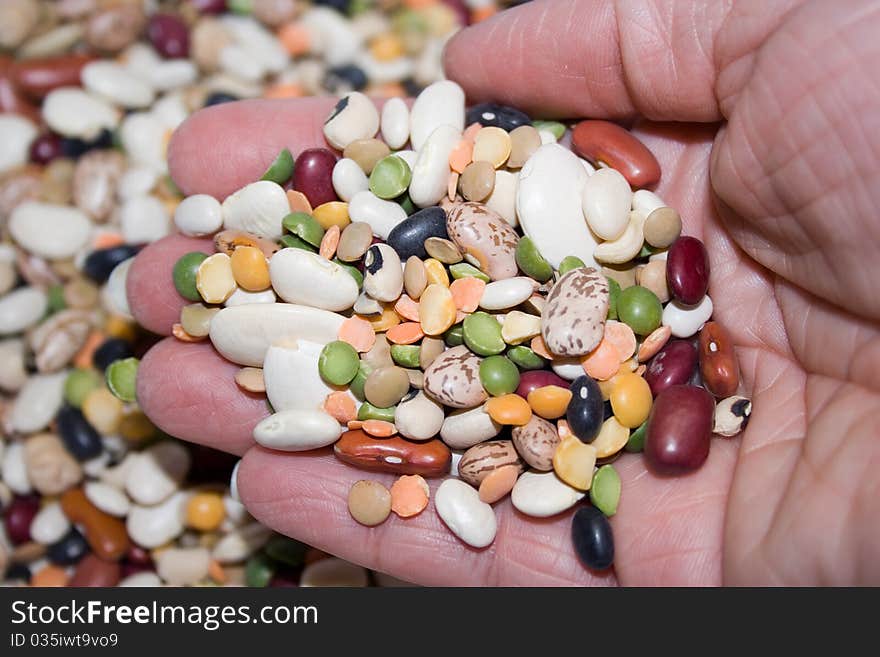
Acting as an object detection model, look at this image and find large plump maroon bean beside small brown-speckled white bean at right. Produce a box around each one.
[645,386,715,476]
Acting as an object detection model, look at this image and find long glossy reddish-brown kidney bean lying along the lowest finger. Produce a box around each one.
[333,429,452,477]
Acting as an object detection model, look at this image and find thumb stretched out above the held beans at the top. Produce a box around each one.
[444,0,792,121]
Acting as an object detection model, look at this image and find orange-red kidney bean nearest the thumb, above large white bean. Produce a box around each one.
[571,121,660,187]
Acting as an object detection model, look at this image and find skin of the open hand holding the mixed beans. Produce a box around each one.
[128,0,880,585]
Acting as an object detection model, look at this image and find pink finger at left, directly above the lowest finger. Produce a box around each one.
[137,338,269,454]
